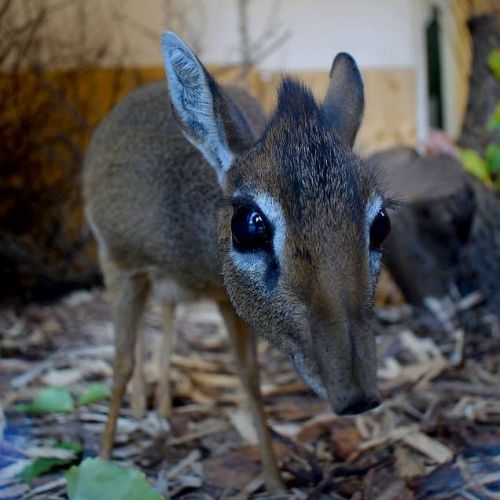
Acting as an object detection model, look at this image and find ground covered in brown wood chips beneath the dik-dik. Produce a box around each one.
[0,291,500,499]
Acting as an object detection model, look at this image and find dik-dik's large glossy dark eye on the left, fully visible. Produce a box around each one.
[231,207,270,251]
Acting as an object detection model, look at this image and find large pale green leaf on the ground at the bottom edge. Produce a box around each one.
[66,458,162,500]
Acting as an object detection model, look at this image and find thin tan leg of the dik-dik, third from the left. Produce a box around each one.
[155,302,175,418]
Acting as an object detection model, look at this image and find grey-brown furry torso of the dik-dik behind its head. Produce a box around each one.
[83,82,266,295]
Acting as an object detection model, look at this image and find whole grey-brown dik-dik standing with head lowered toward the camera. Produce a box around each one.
[84,33,390,491]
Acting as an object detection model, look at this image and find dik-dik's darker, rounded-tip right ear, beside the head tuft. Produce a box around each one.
[323,52,365,147]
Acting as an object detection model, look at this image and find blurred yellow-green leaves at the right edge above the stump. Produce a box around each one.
[458,49,500,192]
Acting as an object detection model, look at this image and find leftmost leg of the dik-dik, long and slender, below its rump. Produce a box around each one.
[101,275,149,458]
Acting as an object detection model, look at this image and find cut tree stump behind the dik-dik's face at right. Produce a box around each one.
[370,148,500,305]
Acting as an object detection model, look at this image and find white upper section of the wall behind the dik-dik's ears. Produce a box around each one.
[192,0,417,71]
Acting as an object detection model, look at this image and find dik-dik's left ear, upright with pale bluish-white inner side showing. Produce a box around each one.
[162,32,254,182]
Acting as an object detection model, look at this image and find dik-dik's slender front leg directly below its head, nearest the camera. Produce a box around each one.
[219,304,285,493]
